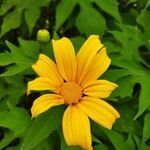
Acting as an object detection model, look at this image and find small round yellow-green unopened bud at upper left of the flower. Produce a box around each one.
[37,29,50,43]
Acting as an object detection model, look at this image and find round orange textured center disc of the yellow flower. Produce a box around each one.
[60,81,82,105]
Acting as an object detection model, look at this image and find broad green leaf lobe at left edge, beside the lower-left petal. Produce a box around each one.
[0,103,31,136]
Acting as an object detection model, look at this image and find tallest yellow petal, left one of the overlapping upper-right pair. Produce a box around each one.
[77,35,103,83]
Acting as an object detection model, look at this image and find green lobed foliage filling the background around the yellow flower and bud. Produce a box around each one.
[0,0,150,150]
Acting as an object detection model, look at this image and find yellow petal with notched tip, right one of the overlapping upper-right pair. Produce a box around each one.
[81,48,111,87]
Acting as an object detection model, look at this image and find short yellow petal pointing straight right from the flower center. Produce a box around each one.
[83,80,118,98]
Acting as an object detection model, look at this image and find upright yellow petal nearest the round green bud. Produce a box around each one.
[52,37,76,81]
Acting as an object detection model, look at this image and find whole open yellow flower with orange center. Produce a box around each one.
[27,35,120,150]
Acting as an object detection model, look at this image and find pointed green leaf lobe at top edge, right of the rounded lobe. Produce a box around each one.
[92,0,121,22]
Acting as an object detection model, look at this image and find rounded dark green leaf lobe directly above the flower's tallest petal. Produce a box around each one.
[76,1,106,36]
